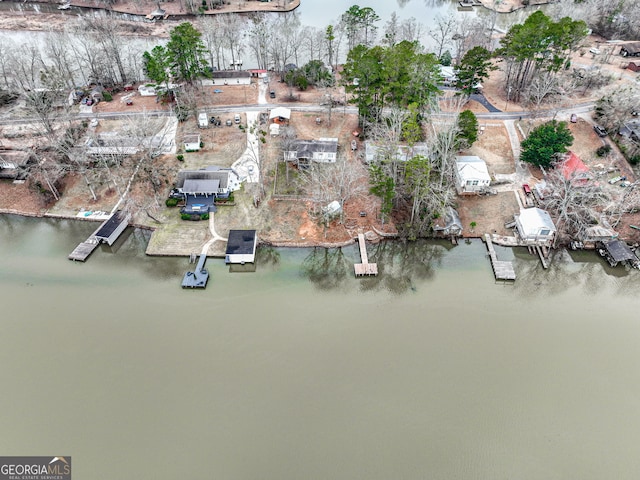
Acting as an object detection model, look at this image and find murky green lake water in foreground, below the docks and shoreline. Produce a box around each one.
[0,215,640,480]
